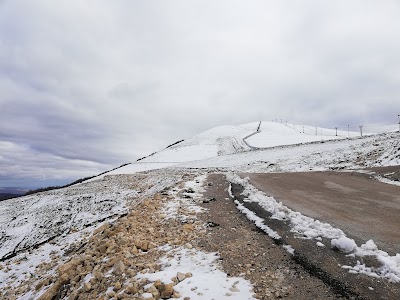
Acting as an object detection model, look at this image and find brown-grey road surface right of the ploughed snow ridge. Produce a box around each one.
[241,168,400,255]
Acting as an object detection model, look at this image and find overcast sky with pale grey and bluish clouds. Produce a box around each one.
[0,0,400,186]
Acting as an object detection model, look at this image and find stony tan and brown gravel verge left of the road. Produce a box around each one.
[0,171,395,300]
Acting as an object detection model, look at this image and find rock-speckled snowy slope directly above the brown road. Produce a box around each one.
[178,132,400,172]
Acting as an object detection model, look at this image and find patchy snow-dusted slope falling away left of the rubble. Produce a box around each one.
[0,172,180,259]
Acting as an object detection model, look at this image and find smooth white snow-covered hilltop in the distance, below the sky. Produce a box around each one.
[90,122,358,181]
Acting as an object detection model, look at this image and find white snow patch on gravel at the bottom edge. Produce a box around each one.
[136,247,255,300]
